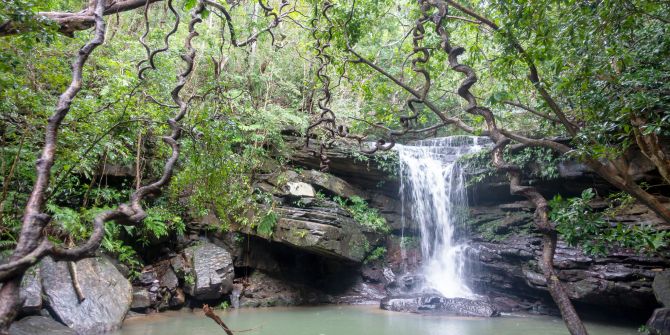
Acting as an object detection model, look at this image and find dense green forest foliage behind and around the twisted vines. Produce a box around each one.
[0,0,670,294]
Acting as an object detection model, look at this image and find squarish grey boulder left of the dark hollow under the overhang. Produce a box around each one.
[184,242,235,300]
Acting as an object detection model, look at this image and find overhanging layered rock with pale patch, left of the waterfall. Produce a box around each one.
[248,170,382,263]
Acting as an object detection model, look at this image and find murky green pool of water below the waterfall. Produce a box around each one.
[114,306,637,335]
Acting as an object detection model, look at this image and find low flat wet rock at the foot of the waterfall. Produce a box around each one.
[380,294,500,317]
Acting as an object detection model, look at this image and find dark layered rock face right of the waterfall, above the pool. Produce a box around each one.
[469,202,670,315]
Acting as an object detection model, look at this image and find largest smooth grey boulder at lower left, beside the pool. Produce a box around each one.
[40,257,133,334]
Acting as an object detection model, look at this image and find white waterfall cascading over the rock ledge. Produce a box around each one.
[397,136,490,298]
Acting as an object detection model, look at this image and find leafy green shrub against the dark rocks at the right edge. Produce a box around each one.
[550,189,670,255]
